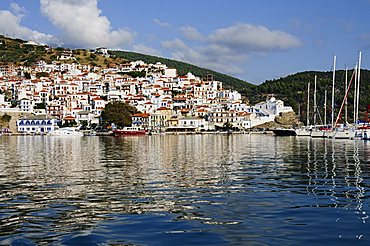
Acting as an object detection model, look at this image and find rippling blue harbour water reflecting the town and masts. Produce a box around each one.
[0,135,370,244]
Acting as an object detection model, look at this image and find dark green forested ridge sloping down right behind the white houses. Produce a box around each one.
[109,51,256,92]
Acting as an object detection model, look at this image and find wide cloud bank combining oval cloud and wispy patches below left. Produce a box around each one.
[161,24,301,76]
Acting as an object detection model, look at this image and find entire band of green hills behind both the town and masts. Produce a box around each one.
[0,35,370,126]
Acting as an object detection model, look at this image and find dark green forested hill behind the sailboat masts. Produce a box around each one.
[241,69,370,125]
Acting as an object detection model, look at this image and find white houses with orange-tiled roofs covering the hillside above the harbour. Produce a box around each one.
[0,48,292,132]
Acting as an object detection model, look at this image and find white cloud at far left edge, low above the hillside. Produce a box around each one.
[0,9,56,44]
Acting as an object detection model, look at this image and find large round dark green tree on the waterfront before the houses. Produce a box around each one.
[101,102,138,127]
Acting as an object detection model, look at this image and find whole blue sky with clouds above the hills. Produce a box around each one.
[0,0,370,84]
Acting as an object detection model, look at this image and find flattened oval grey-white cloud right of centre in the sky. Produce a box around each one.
[209,24,301,52]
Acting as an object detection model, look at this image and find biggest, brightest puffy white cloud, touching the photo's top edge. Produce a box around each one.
[40,0,134,48]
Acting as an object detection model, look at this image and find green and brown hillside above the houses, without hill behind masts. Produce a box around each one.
[0,35,255,92]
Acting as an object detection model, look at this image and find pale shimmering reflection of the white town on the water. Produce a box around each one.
[0,135,249,238]
